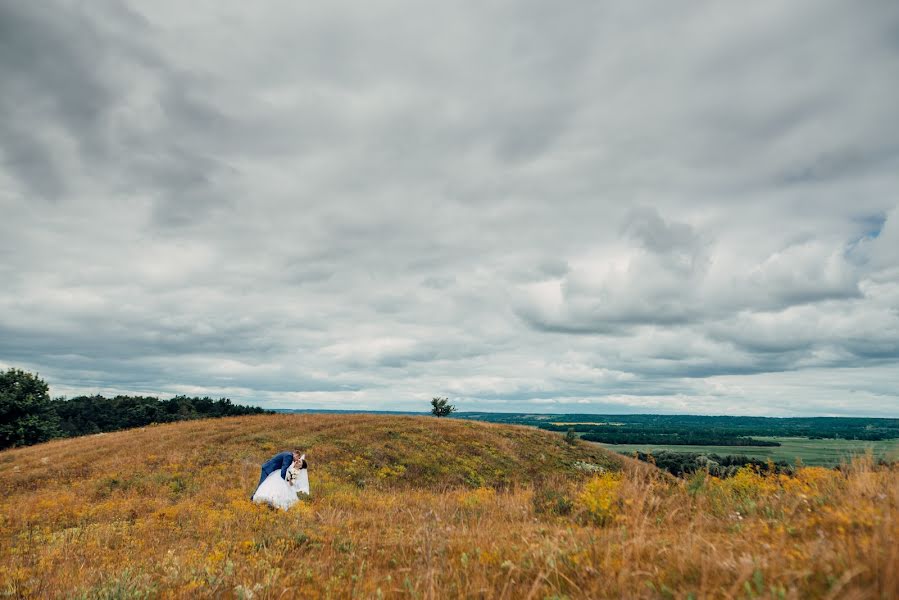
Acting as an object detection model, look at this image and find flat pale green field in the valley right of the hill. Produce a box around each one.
[600,437,899,467]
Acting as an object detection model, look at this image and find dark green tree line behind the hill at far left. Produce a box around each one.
[0,369,269,449]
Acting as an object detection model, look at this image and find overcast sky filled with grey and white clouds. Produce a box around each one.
[0,0,899,417]
